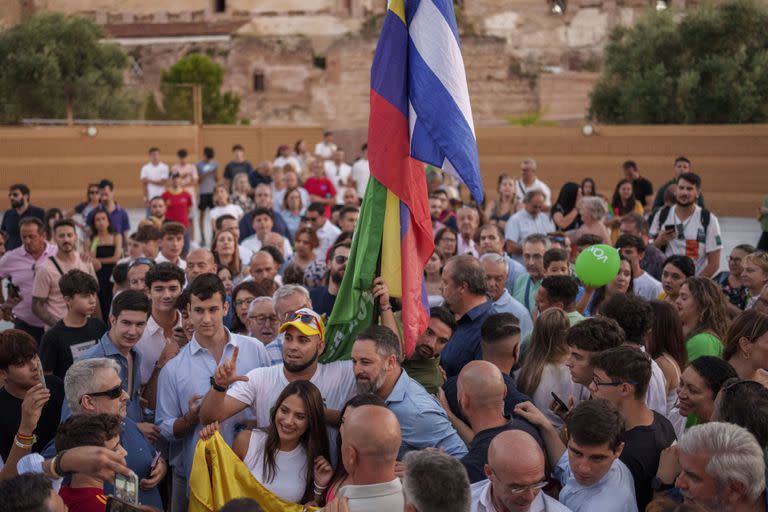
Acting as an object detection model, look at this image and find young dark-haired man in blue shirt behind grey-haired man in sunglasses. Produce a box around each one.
[80,290,154,443]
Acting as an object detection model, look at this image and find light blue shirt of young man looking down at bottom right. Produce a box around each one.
[554,450,637,512]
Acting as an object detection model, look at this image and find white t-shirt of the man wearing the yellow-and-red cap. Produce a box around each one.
[227,361,355,428]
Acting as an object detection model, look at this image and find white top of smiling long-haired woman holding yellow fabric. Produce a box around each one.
[243,429,307,503]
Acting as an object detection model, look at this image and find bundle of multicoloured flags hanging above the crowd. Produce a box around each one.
[322,0,483,362]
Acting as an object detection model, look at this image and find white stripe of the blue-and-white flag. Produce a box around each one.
[408,0,475,135]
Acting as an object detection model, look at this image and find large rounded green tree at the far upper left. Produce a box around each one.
[0,13,133,123]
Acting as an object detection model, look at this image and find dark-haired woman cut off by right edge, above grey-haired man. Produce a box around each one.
[723,309,768,387]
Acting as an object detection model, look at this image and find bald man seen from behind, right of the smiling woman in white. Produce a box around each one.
[338,405,405,512]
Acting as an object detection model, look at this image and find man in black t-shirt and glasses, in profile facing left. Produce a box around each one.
[590,345,676,510]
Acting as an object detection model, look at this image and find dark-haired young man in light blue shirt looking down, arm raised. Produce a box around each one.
[515,398,637,512]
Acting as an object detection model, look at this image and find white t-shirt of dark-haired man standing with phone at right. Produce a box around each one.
[650,205,723,275]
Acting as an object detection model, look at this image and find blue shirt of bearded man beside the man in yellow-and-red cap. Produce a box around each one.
[385,370,467,460]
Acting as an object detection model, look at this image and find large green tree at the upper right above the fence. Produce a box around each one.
[589,0,768,124]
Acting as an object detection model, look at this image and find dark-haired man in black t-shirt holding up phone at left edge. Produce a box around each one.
[0,329,64,460]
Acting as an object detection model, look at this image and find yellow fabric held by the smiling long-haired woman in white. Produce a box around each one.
[189,432,319,512]
